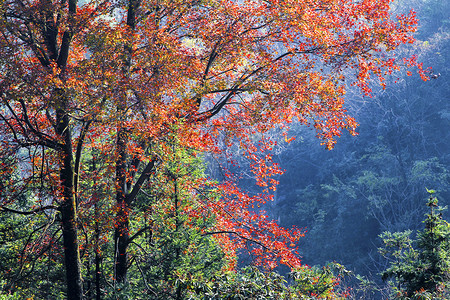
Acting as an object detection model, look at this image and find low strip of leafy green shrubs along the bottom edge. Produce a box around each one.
[105,264,348,300]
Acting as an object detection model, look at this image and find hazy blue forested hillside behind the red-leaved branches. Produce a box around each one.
[268,1,450,296]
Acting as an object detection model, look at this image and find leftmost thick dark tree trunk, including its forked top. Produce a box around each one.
[50,0,83,292]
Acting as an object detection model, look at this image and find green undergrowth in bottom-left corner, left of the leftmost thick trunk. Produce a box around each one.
[0,204,64,299]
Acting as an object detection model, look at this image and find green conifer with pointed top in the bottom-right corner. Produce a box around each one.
[379,190,450,299]
